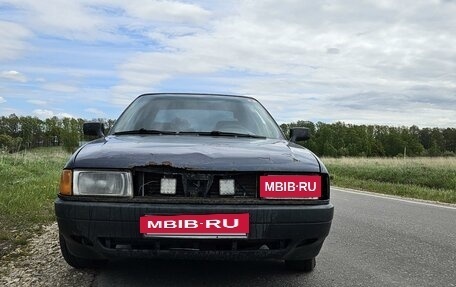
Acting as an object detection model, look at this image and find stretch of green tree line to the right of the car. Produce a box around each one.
[281,121,456,157]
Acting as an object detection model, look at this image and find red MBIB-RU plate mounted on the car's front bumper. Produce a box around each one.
[139,213,250,238]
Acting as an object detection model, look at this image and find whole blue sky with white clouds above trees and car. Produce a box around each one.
[0,0,456,128]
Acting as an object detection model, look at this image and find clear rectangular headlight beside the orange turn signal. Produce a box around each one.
[73,170,133,196]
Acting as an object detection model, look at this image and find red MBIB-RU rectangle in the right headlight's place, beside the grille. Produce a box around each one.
[260,175,321,199]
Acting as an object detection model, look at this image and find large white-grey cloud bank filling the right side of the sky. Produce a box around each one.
[110,1,456,125]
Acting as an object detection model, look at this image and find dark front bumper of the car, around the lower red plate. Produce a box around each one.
[55,198,334,260]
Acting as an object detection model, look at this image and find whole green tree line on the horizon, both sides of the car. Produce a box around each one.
[0,114,456,157]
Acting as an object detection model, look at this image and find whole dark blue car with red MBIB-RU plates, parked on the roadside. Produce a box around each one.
[55,94,333,272]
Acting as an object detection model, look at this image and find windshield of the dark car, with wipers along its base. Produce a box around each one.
[110,94,283,138]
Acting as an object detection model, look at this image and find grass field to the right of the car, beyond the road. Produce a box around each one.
[323,157,456,203]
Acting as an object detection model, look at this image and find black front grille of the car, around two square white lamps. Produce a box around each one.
[134,171,258,198]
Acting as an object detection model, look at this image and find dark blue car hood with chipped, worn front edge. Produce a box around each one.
[67,135,324,172]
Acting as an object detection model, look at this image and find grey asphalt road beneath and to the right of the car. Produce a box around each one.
[93,189,456,287]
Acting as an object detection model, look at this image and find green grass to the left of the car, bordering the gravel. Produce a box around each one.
[0,148,69,258]
